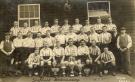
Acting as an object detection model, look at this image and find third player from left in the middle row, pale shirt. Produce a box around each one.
[34,32,43,49]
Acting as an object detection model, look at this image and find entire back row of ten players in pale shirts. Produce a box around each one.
[10,18,117,36]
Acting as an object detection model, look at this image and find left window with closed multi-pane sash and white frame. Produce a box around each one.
[18,4,40,27]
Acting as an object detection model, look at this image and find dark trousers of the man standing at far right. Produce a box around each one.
[120,49,130,72]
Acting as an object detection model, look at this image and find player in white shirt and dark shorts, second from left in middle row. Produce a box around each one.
[23,31,35,60]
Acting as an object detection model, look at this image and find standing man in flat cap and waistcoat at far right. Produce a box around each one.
[117,27,132,75]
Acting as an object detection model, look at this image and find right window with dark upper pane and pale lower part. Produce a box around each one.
[87,1,111,20]
